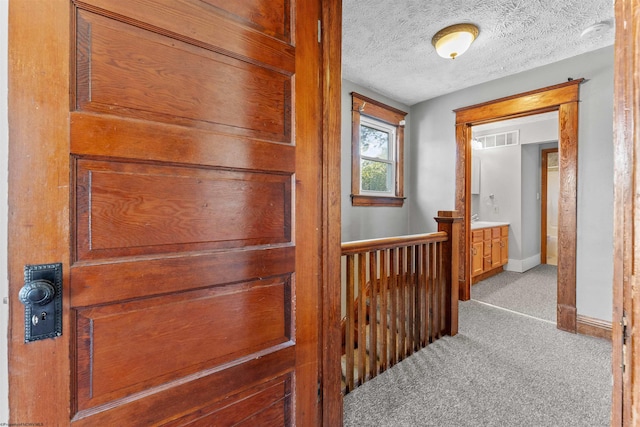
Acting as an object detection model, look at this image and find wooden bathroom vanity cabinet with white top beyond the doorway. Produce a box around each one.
[471,222,509,283]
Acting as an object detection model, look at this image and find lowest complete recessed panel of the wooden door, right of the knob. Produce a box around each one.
[76,278,291,409]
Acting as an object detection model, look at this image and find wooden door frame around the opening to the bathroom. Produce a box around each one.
[454,79,584,333]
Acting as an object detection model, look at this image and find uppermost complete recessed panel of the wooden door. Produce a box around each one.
[76,11,294,143]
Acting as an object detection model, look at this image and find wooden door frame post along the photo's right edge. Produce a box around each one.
[611,0,640,426]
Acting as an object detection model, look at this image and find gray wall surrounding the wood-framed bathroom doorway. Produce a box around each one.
[407,46,613,320]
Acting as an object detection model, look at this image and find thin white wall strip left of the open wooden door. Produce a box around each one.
[0,0,9,423]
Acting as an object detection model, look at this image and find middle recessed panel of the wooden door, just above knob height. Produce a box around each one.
[76,159,291,261]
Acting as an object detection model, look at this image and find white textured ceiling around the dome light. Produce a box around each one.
[342,0,614,105]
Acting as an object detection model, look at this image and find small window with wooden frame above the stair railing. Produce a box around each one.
[351,92,407,206]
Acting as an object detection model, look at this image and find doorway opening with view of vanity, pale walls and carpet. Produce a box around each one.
[471,111,558,325]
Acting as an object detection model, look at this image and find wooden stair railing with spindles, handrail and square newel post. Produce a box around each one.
[342,211,462,394]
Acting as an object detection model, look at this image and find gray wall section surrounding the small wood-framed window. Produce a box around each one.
[341,80,412,242]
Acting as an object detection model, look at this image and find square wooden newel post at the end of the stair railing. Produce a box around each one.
[434,211,462,336]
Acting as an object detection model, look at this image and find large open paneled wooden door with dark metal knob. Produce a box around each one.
[9,0,322,426]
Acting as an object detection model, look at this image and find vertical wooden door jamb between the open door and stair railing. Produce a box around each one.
[319,0,343,426]
